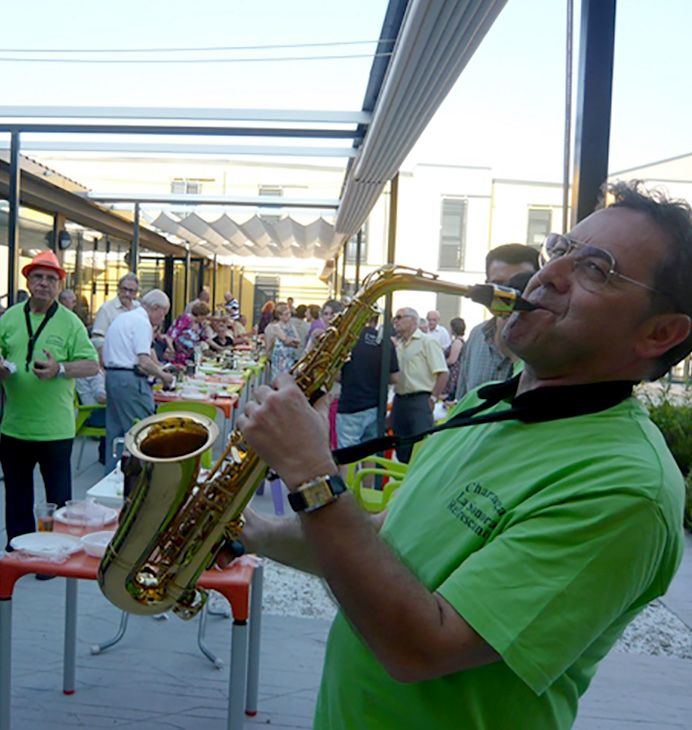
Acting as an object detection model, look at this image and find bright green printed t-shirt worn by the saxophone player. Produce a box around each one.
[315,393,684,730]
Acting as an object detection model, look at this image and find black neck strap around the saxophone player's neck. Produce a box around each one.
[332,375,635,464]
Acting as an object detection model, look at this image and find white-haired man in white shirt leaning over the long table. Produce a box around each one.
[103,289,173,473]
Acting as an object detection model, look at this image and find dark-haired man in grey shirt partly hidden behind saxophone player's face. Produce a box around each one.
[456,243,538,400]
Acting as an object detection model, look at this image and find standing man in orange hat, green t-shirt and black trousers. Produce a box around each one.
[0,251,98,543]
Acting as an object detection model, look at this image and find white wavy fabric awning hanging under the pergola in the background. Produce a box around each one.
[150,212,334,259]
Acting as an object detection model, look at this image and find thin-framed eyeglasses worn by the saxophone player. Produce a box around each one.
[541,233,674,301]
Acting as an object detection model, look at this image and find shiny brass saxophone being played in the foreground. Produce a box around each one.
[98,266,534,619]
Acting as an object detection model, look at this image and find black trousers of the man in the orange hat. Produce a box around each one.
[0,434,73,544]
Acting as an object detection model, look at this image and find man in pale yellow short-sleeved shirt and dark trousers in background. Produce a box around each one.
[392,307,449,462]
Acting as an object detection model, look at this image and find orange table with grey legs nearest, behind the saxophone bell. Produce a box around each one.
[0,552,262,730]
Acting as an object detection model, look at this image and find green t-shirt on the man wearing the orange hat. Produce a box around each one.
[0,304,98,441]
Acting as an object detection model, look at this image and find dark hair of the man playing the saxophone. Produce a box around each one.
[598,180,692,380]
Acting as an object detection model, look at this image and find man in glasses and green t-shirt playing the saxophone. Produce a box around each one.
[220,183,692,730]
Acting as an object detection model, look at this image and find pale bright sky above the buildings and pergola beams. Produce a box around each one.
[0,0,692,181]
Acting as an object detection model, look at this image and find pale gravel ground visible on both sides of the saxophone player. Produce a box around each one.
[262,560,692,659]
